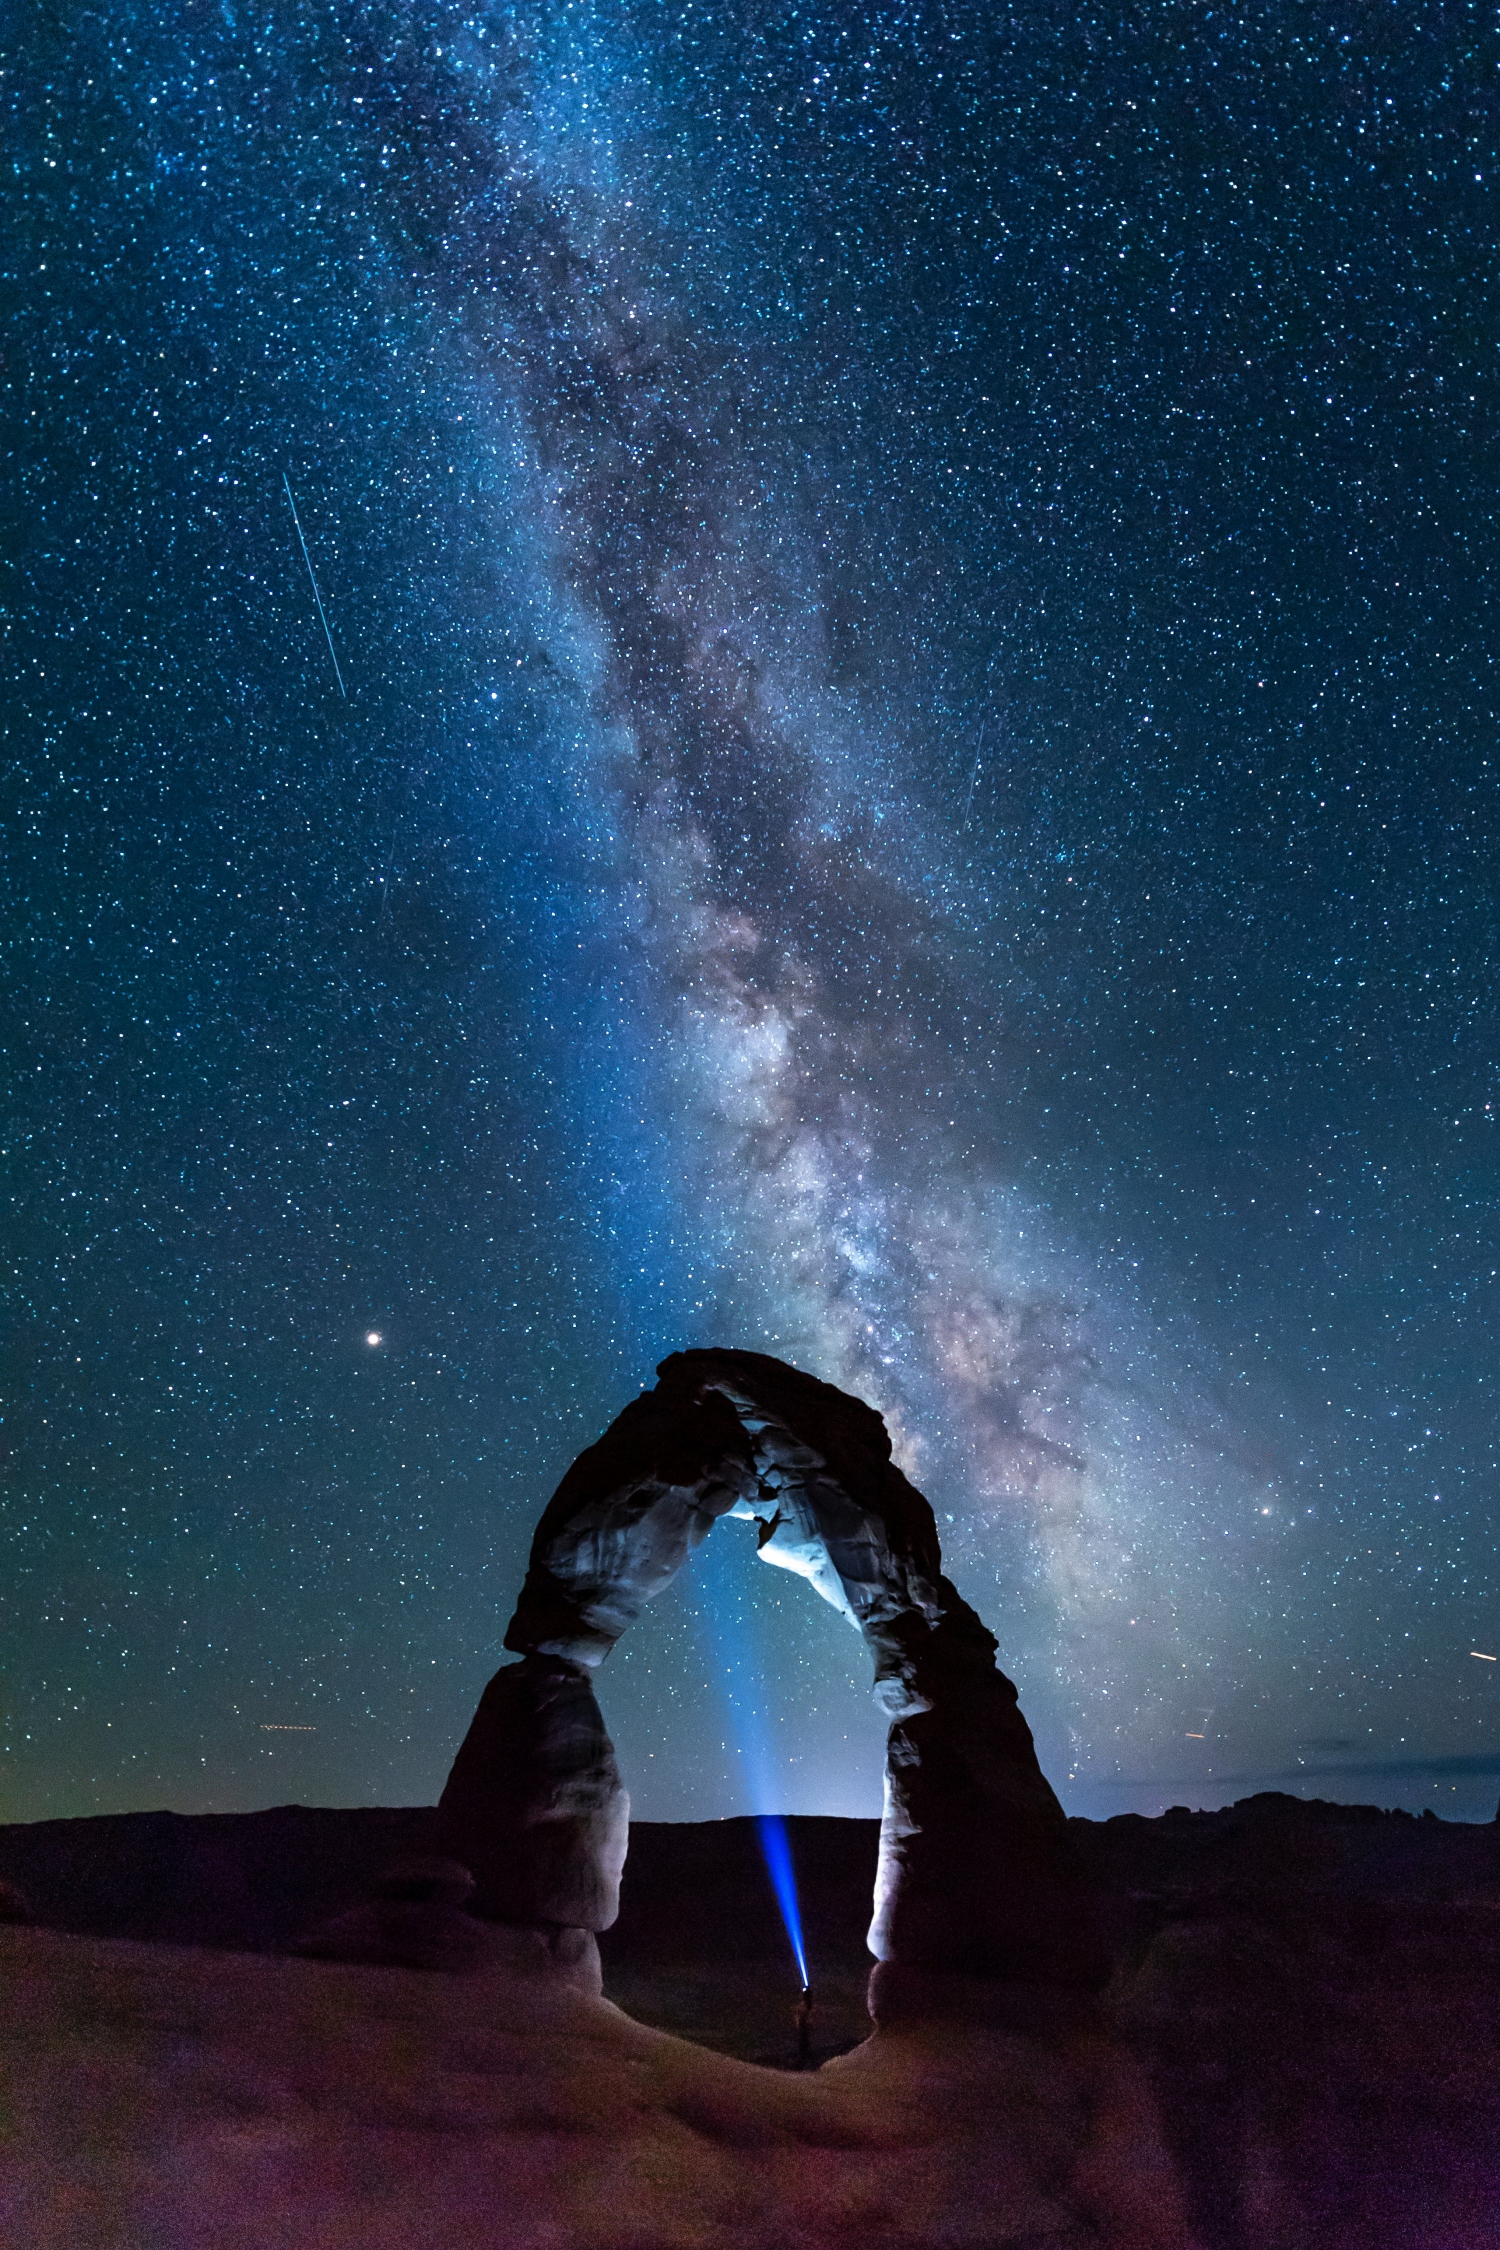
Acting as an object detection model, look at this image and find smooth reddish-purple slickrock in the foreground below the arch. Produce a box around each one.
[0,1928,1187,2250]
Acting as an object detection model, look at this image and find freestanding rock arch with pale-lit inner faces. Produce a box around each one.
[443,1352,1093,1985]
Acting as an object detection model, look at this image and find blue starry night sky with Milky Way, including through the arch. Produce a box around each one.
[11,0,1500,1820]
